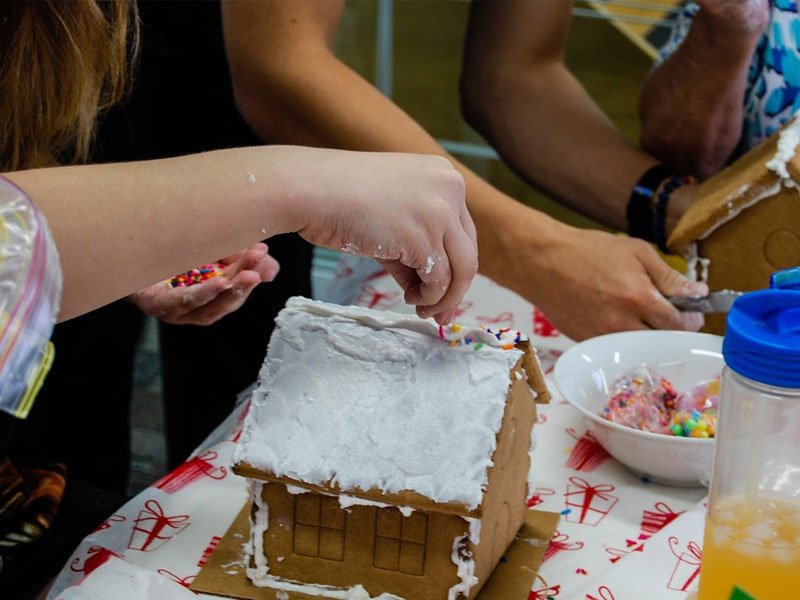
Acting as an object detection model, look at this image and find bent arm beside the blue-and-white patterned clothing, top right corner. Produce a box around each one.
[639,0,770,178]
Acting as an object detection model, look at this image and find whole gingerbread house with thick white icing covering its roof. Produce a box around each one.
[228,298,549,600]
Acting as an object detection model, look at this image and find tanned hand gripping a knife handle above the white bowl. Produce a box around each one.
[516,224,708,340]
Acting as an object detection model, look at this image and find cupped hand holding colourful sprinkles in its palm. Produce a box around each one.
[128,243,280,325]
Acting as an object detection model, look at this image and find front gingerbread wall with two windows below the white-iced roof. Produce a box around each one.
[262,483,469,599]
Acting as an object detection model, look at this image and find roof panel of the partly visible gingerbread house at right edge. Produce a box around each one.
[668,116,800,252]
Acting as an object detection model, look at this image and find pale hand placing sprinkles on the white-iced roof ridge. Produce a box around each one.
[299,152,478,323]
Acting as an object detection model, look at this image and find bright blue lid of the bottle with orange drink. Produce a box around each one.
[722,267,800,388]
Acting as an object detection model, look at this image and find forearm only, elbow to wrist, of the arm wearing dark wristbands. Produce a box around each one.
[462,62,656,230]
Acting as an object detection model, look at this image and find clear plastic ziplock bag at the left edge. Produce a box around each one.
[0,176,62,418]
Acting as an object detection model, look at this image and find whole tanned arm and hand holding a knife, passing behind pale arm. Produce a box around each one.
[223,0,702,339]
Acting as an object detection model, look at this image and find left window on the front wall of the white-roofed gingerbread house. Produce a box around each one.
[294,494,346,562]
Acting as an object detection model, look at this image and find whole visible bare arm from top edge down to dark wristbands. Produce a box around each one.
[461,0,664,231]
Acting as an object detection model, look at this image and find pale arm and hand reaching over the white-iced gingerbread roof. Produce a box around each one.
[6,146,477,321]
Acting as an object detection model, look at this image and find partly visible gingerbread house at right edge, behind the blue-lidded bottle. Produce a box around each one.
[668,117,800,333]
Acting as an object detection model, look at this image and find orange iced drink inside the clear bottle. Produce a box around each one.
[698,497,800,600]
